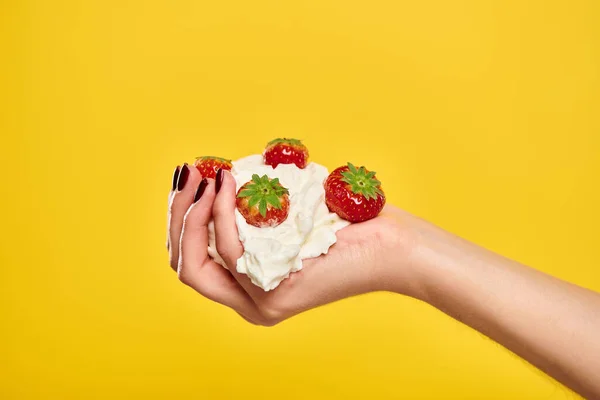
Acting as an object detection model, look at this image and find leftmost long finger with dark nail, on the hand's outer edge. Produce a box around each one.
[169,164,201,270]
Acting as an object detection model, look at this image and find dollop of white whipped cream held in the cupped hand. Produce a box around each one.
[208,155,350,291]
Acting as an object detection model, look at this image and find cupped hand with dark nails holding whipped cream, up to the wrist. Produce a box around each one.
[169,168,411,326]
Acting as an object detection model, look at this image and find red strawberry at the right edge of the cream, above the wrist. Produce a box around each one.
[325,163,385,222]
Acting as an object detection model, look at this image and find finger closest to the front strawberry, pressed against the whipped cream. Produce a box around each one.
[213,171,244,268]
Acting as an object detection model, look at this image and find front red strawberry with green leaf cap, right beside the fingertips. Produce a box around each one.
[235,174,290,228]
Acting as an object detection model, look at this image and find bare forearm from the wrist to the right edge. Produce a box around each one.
[390,216,600,398]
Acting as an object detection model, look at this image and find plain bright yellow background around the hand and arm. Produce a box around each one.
[0,0,600,399]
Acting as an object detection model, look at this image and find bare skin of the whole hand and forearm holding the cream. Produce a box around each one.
[168,168,600,399]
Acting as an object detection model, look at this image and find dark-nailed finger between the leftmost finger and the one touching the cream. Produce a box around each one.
[178,179,260,321]
